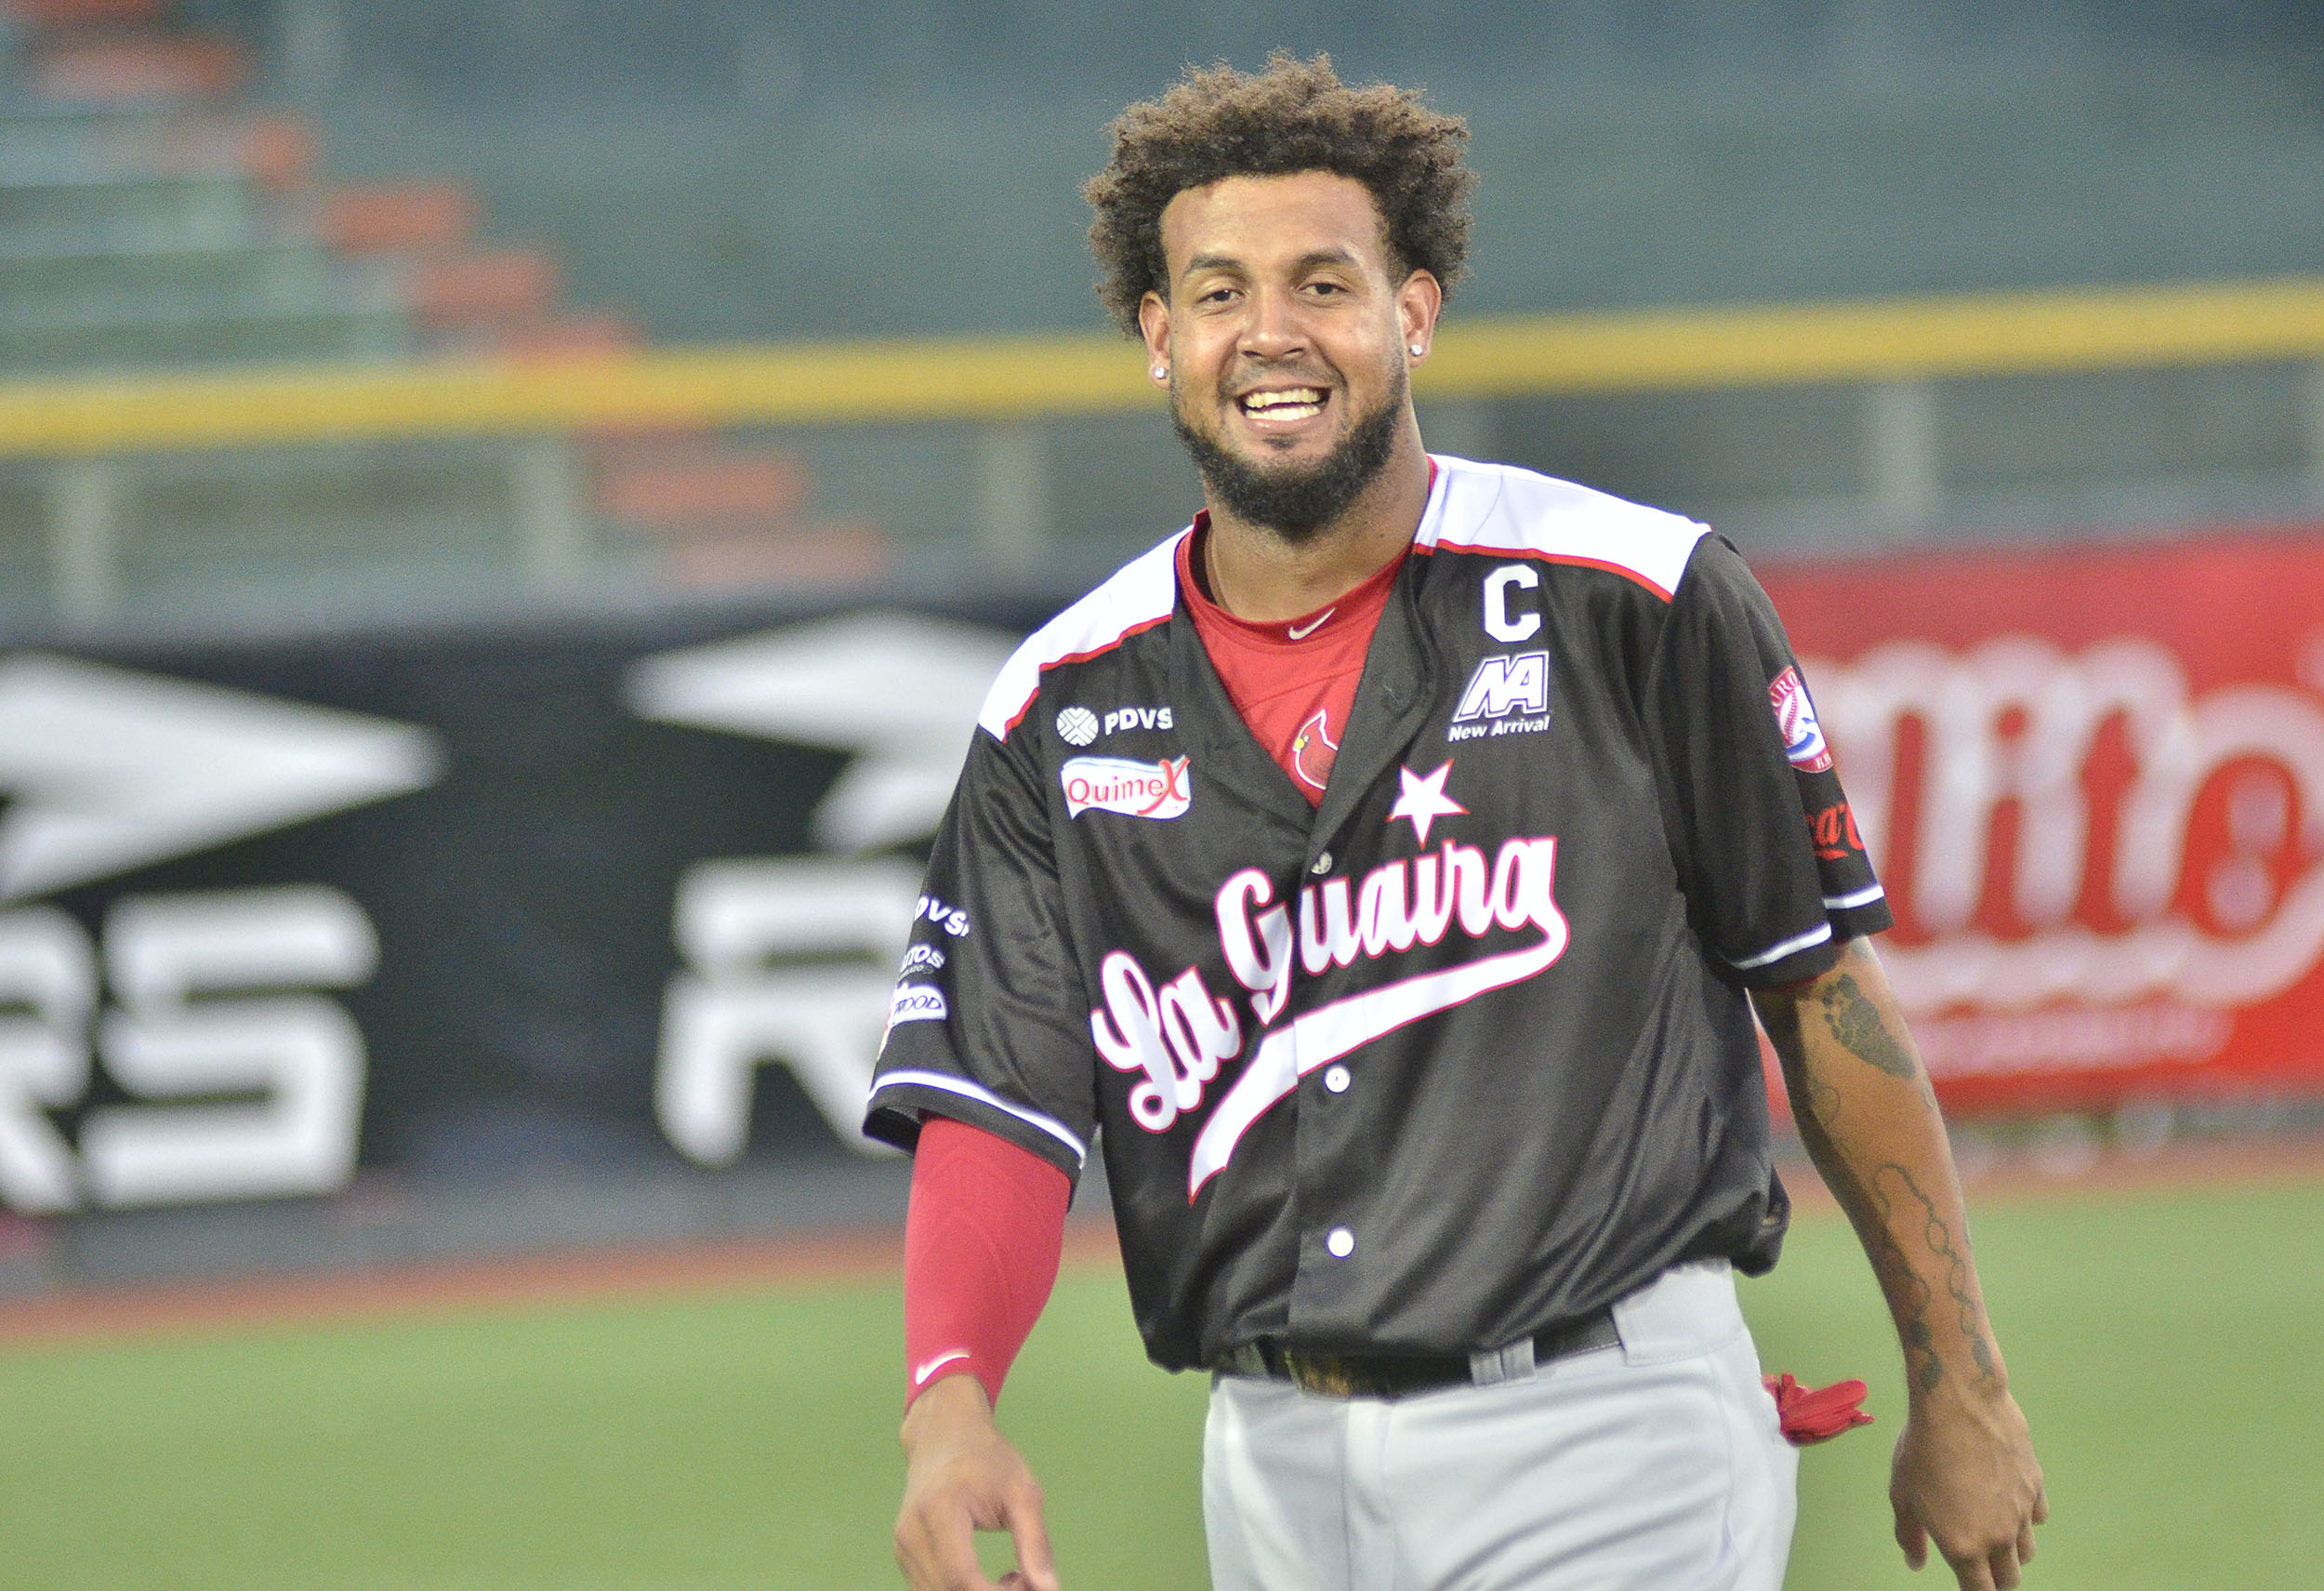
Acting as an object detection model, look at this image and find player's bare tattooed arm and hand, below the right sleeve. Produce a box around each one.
[1752,940,2050,1591]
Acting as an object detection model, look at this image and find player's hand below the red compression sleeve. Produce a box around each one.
[895,1374,1058,1591]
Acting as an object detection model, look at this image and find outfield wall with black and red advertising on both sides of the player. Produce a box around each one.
[0,535,2324,1216]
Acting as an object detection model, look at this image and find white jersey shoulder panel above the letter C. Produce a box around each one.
[1413,454,1710,603]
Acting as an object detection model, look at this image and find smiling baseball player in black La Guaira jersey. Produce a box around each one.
[867,56,2045,1591]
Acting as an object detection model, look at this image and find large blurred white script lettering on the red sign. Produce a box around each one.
[1811,635,2324,1023]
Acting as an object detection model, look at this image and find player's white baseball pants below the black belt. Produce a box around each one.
[1202,1261,1799,1591]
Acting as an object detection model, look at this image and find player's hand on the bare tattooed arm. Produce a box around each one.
[1890,1388,2050,1591]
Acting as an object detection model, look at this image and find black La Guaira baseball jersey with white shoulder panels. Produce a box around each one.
[867,458,1890,1370]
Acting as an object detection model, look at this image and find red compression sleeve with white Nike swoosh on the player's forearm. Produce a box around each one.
[905,1117,1074,1407]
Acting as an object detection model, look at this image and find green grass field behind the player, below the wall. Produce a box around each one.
[0,1188,2324,1591]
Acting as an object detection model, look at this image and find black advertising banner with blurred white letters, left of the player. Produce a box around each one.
[0,604,1041,1214]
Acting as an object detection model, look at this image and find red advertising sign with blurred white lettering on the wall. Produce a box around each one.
[1764,535,2324,1112]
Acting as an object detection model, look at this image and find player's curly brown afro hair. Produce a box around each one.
[1081,51,1476,338]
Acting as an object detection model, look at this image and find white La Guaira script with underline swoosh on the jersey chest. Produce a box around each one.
[1090,838,1571,1198]
